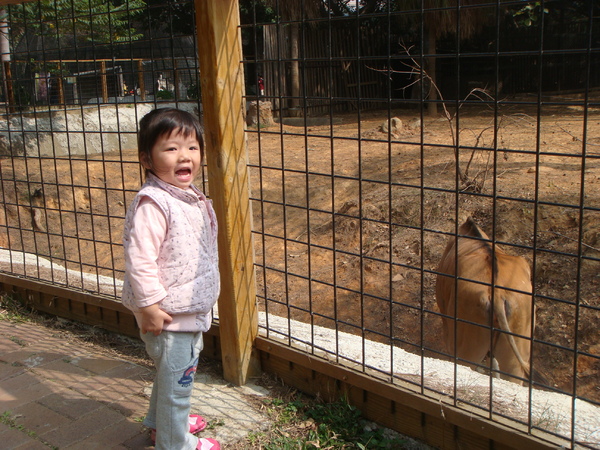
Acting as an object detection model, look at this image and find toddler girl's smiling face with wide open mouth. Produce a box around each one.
[141,129,202,189]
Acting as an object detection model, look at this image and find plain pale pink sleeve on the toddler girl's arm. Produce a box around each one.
[125,197,167,308]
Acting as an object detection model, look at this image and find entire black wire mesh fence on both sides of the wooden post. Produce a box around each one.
[0,0,600,448]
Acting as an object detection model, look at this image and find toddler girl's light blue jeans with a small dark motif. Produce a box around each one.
[141,331,203,450]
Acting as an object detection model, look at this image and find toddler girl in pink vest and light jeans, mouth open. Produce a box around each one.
[122,108,220,450]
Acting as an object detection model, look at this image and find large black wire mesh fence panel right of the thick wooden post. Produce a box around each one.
[242,1,600,447]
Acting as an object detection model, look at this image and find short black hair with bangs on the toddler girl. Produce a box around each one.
[138,108,204,174]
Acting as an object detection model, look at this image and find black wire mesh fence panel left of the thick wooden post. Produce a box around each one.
[0,1,201,297]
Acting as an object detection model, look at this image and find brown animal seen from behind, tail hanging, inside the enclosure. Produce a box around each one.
[436,217,535,382]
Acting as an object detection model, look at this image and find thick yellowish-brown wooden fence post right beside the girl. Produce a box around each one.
[195,0,259,385]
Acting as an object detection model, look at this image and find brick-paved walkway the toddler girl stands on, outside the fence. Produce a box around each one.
[0,318,269,450]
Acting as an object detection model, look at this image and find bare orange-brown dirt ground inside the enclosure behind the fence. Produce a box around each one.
[0,99,600,402]
